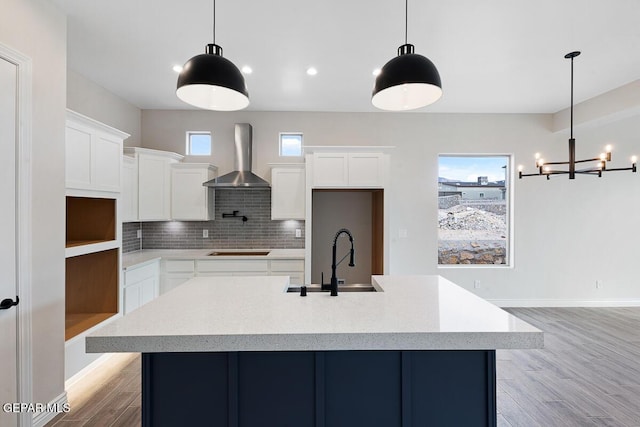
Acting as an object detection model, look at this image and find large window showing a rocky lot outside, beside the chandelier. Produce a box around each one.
[438,155,511,265]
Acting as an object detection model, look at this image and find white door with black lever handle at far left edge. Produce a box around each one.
[0,57,18,427]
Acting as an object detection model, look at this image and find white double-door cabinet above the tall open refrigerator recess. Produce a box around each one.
[312,151,388,188]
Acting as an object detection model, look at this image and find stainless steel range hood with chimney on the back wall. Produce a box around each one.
[202,123,269,189]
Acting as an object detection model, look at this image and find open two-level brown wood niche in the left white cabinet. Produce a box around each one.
[65,195,120,341]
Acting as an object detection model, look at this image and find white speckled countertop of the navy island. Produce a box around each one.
[86,276,543,353]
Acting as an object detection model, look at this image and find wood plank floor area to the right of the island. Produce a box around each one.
[497,308,640,427]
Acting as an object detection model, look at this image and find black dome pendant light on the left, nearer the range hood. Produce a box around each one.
[176,0,249,111]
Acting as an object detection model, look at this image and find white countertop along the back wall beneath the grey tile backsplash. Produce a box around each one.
[122,249,304,270]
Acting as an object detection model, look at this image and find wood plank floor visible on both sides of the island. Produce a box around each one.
[47,308,640,427]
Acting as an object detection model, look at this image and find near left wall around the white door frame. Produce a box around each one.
[0,0,67,408]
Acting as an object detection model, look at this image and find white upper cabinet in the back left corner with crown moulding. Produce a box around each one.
[124,147,183,221]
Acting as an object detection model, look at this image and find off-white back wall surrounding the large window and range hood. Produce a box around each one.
[142,110,640,305]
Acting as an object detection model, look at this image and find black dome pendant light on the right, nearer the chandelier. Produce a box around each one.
[371,0,442,111]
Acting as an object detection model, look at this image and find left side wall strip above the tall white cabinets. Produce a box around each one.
[67,70,142,147]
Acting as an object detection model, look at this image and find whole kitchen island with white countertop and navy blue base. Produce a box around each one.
[87,276,543,427]
